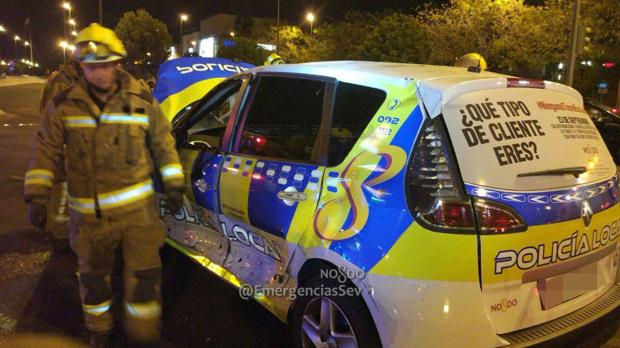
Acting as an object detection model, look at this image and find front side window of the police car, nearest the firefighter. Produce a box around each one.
[185,80,242,147]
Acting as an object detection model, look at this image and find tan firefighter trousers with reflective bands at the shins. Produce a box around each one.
[69,196,165,342]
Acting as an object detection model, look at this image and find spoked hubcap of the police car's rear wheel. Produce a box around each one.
[301,297,357,348]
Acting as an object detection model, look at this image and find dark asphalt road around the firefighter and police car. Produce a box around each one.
[0,79,620,348]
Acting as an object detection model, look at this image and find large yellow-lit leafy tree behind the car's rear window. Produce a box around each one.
[418,0,569,77]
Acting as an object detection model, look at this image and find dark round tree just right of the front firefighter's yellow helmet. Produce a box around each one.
[114,9,172,77]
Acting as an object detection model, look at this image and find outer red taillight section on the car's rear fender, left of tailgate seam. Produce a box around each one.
[421,201,474,228]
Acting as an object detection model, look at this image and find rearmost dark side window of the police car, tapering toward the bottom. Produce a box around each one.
[328,82,386,166]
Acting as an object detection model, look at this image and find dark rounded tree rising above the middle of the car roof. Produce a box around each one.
[361,13,431,63]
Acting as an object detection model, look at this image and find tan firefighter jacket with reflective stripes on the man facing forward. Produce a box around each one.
[25,69,183,220]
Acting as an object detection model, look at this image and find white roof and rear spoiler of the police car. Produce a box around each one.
[252,61,582,117]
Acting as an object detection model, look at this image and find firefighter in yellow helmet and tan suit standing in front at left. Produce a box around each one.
[25,24,183,346]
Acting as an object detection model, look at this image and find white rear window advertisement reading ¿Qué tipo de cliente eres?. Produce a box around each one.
[443,88,616,191]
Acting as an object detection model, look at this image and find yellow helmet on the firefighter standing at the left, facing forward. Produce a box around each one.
[75,23,127,63]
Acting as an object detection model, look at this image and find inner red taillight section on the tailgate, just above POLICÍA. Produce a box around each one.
[475,200,526,234]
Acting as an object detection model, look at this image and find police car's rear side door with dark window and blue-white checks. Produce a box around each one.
[219,74,333,286]
